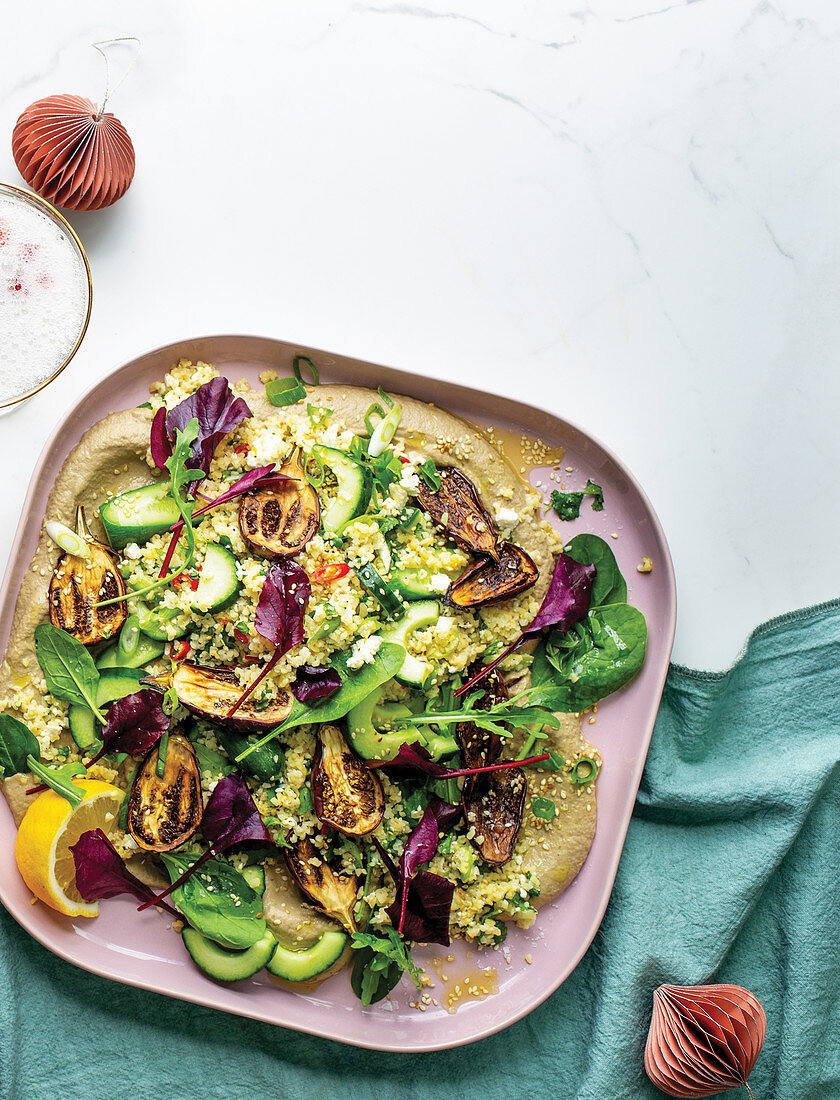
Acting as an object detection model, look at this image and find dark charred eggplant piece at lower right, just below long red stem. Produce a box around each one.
[461,768,528,867]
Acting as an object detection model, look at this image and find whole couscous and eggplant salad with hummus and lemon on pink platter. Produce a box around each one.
[0,356,646,1005]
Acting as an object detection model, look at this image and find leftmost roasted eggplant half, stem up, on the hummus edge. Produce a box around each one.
[49,505,125,646]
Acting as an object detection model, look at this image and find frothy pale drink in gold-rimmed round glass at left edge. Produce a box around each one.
[0,184,90,409]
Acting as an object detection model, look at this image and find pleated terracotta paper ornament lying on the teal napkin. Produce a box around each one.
[644,986,767,1097]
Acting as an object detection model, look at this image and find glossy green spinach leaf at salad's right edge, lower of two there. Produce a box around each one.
[540,604,648,711]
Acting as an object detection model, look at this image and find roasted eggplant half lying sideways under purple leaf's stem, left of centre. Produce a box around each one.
[166,661,294,734]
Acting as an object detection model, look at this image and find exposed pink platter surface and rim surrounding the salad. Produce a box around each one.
[0,336,676,1052]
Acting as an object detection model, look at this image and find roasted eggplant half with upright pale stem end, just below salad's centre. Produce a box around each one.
[311,725,385,836]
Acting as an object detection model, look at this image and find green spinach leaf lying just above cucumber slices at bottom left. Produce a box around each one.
[161,851,265,950]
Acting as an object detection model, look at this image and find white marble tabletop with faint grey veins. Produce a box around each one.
[0,0,840,668]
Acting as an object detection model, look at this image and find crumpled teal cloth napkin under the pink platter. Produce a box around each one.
[0,602,840,1100]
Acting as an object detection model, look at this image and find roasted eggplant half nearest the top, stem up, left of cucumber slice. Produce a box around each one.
[240,447,321,559]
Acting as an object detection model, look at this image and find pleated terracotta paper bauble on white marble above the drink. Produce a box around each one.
[12,96,134,210]
